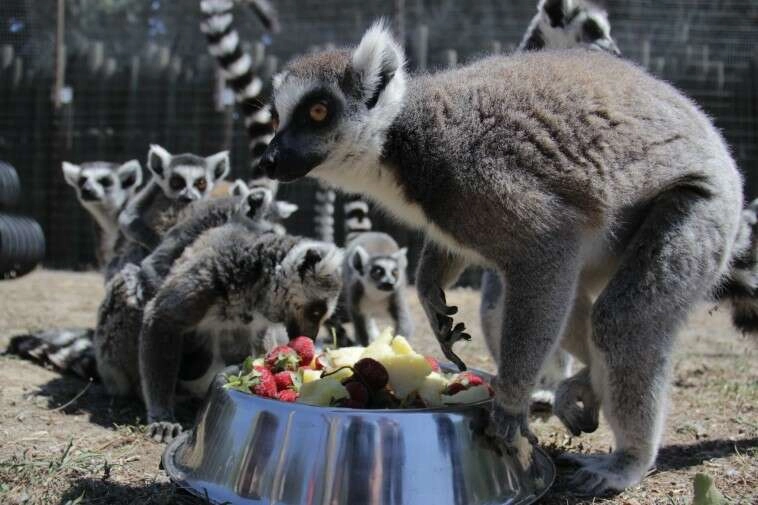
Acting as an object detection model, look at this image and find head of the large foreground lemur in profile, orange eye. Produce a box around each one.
[260,22,407,181]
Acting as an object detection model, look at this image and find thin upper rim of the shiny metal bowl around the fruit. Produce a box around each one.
[218,363,494,415]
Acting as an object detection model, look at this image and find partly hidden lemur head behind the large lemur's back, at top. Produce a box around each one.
[519,0,621,55]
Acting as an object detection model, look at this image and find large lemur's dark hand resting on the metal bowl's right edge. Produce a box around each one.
[487,400,537,471]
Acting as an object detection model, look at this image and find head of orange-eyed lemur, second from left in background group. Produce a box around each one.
[147,144,229,202]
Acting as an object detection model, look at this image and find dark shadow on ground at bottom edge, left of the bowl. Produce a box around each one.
[59,479,211,505]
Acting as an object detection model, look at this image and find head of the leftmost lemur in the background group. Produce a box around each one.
[63,160,142,214]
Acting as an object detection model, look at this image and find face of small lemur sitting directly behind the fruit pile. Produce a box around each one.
[350,246,408,298]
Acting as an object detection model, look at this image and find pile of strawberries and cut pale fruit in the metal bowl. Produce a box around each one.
[225,331,493,409]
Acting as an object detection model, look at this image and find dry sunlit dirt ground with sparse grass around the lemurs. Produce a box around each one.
[0,270,758,505]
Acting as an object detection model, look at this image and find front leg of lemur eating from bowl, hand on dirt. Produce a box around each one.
[139,269,214,441]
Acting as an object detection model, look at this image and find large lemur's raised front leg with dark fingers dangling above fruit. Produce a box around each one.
[416,240,471,370]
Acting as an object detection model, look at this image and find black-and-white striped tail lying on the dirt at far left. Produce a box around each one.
[5,328,99,380]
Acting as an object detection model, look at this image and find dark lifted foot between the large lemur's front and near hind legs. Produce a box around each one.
[553,368,600,436]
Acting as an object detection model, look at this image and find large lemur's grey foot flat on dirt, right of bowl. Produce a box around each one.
[557,452,647,496]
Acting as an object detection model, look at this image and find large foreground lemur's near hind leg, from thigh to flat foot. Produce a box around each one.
[568,188,740,495]
